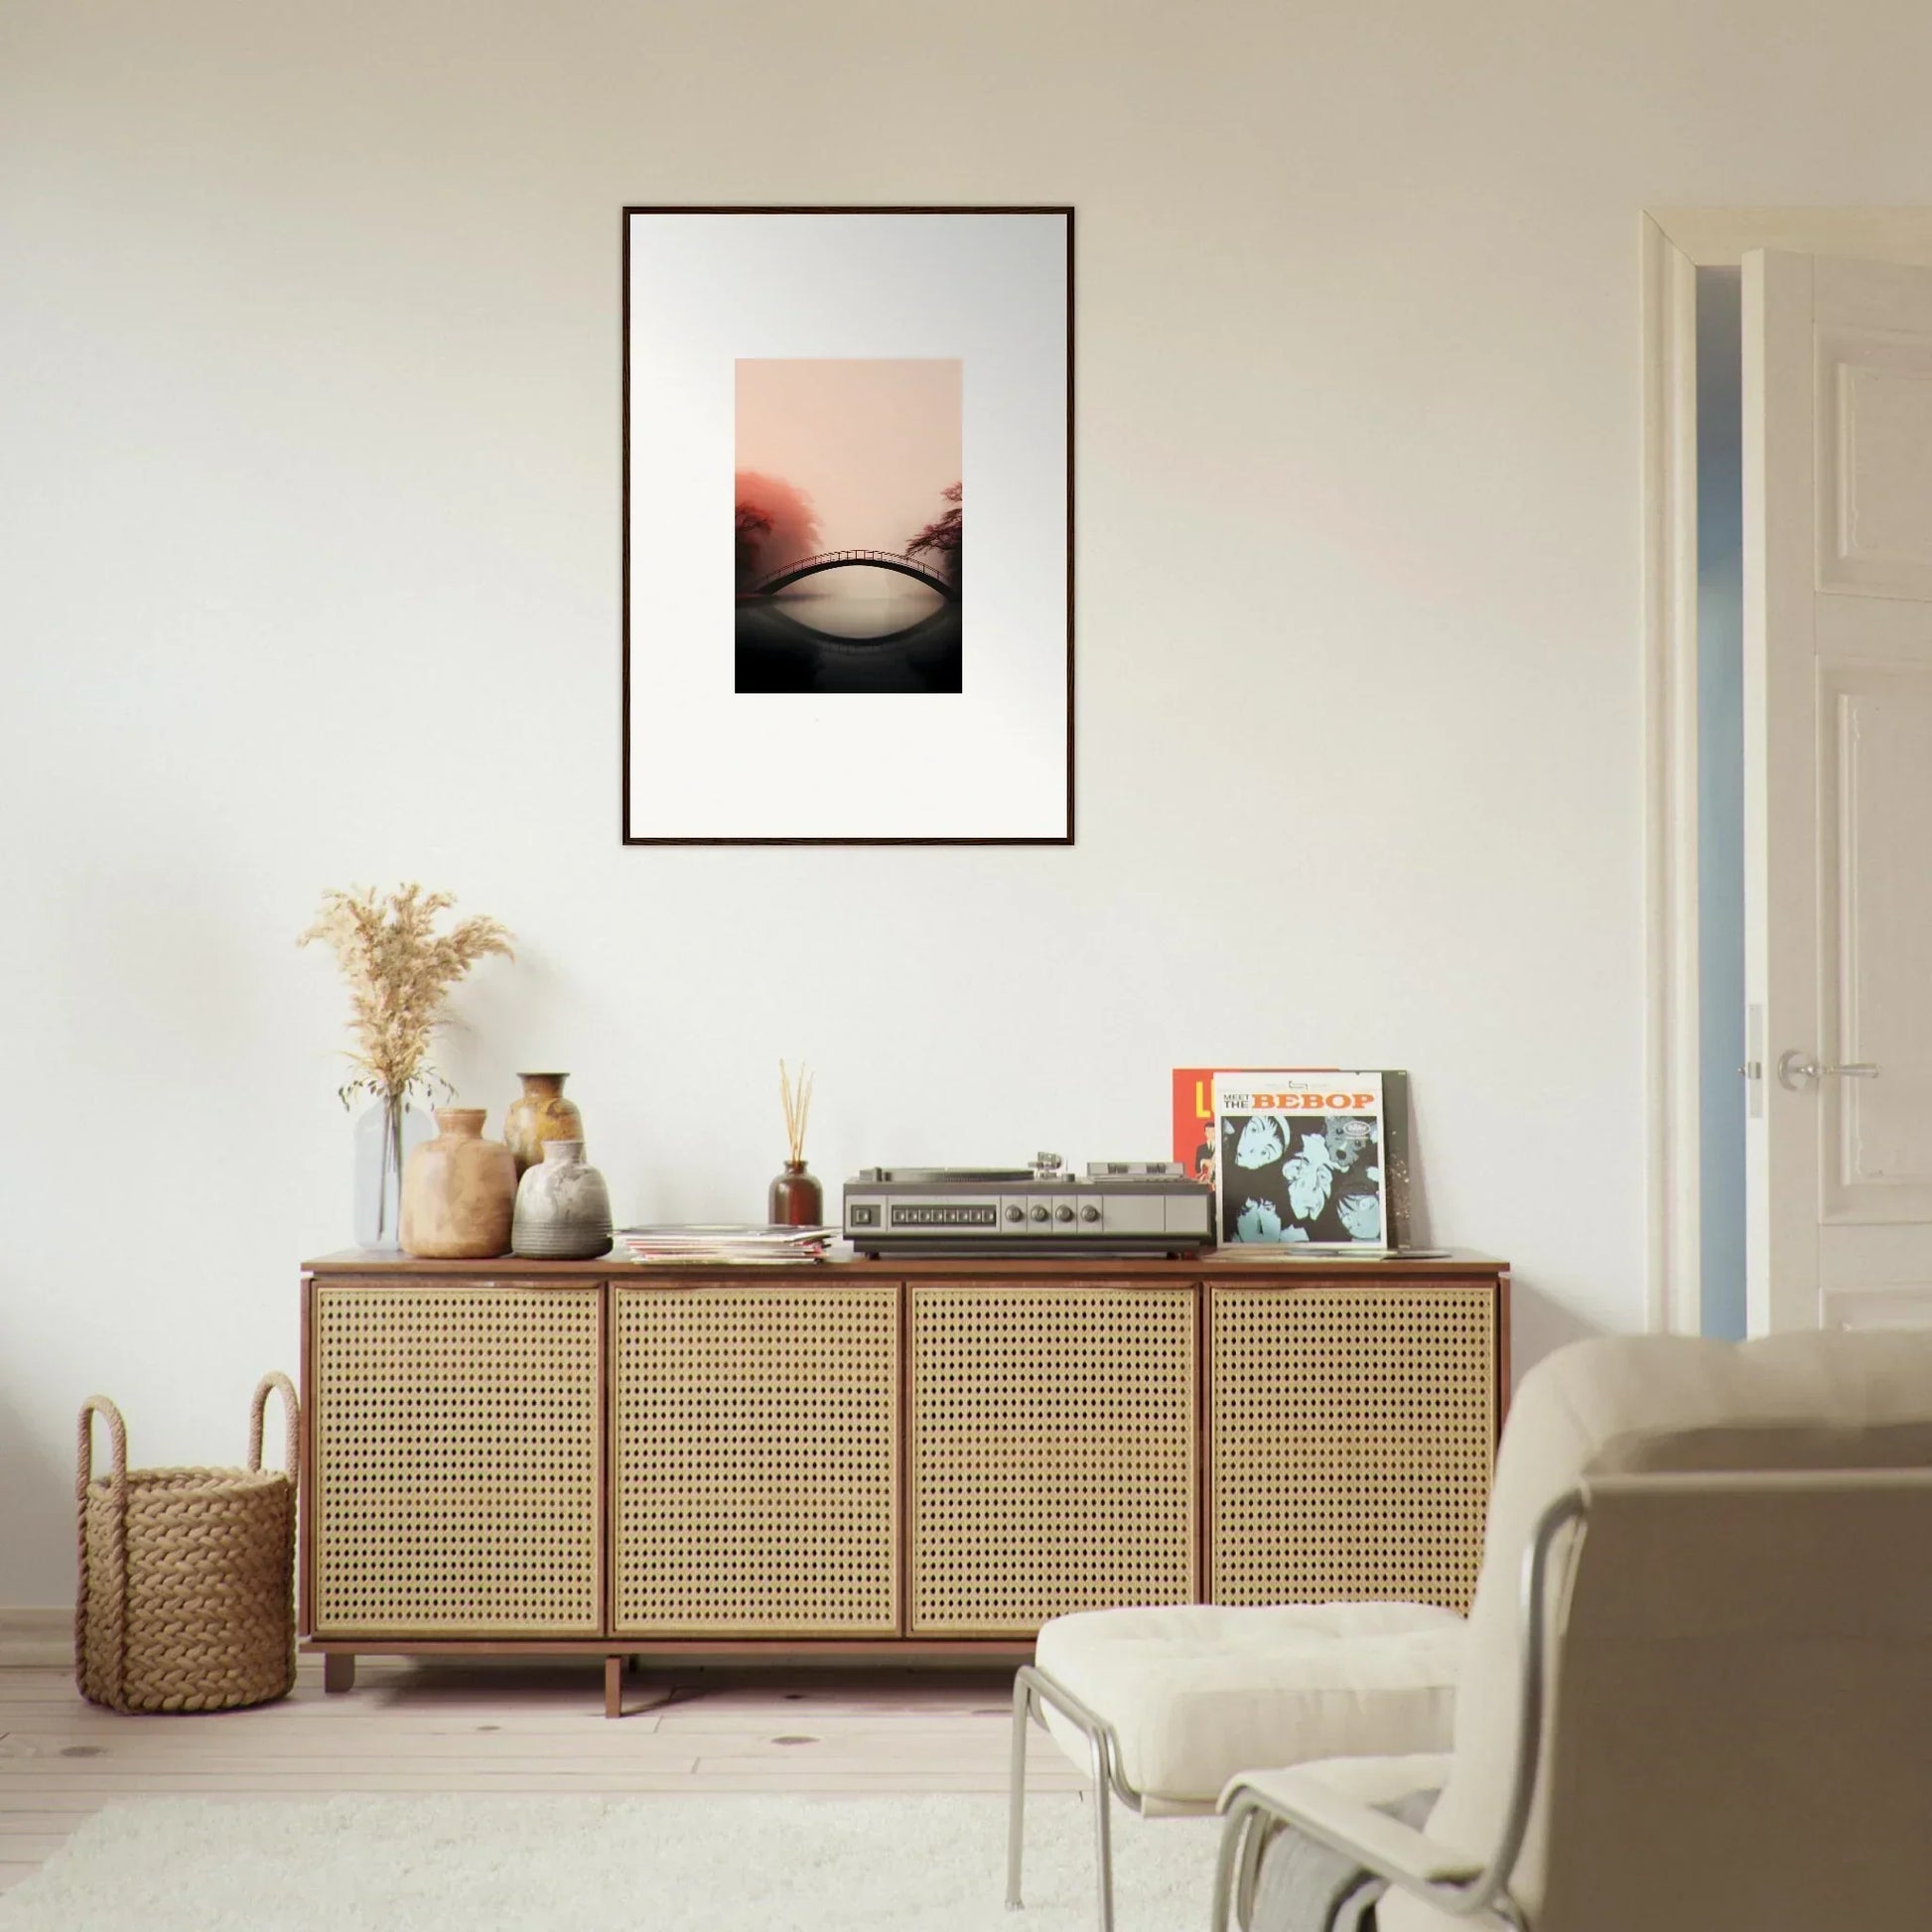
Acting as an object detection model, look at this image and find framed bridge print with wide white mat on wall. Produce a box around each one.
[624,207,1074,844]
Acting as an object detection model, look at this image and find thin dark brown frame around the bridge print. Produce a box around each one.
[619,203,1076,846]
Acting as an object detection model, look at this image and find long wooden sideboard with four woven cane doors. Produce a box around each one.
[300,1252,1509,1712]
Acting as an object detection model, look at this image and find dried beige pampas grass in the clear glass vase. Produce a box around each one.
[296,885,516,1107]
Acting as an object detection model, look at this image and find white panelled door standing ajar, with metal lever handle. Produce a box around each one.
[1744,253,1932,1333]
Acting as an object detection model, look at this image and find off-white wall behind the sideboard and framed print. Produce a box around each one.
[0,0,1932,1603]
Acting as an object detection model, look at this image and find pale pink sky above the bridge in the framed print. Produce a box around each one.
[734,357,960,551]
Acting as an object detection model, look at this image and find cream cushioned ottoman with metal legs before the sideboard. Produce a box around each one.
[1007,1603,1464,1932]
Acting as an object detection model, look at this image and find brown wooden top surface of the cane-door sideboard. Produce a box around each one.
[302,1248,1509,1287]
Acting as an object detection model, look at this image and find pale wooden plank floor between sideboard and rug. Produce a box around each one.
[0,1658,1080,1889]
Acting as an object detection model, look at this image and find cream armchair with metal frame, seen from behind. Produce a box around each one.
[1213,1333,1932,1932]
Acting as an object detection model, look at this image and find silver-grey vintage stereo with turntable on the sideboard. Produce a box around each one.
[844,1154,1213,1256]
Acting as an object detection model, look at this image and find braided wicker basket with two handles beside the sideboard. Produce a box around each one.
[73,1376,298,1710]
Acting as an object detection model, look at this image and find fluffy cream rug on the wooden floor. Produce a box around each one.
[0,1793,1219,1932]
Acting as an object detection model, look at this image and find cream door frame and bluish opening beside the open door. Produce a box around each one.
[1640,207,1932,1337]
